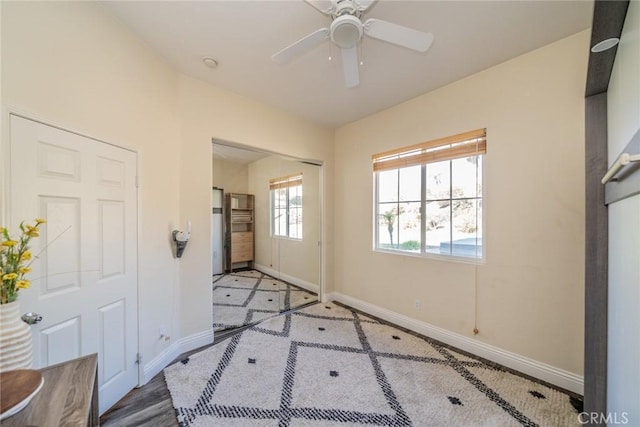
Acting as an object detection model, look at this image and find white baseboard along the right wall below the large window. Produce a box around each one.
[326,292,584,394]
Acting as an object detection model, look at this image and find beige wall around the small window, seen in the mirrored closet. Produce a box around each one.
[249,156,321,286]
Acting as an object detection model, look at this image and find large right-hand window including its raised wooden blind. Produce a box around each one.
[373,129,486,259]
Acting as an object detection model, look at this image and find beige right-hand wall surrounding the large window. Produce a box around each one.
[334,31,589,374]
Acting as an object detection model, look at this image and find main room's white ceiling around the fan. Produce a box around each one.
[106,0,593,128]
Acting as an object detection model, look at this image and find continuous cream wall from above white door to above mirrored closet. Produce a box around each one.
[0,1,333,378]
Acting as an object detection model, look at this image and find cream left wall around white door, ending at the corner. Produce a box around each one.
[2,2,181,368]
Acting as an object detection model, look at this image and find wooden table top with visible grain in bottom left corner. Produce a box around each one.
[2,354,100,427]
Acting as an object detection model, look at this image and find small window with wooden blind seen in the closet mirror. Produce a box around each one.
[269,173,302,239]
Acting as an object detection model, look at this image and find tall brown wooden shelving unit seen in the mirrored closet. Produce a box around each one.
[224,193,255,272]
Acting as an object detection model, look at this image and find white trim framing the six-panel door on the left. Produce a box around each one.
[0,106,144,386]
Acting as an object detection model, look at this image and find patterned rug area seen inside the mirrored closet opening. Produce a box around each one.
[213,270,318,331]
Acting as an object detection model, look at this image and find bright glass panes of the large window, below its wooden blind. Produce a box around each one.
[376,155,483,258]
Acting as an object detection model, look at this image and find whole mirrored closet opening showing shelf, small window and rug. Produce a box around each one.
[212,139,322,332]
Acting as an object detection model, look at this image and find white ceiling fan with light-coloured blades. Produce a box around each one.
[271,0,433,88]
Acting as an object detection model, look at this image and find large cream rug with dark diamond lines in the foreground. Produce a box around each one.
[164,303,581,427]
